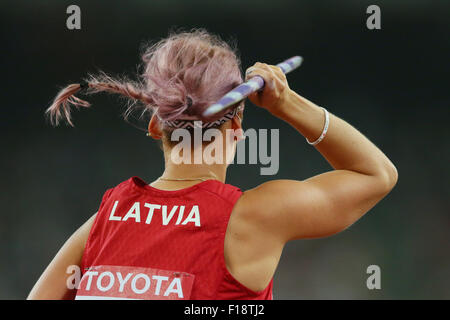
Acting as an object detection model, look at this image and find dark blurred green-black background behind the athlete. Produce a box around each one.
[0,0,450,299]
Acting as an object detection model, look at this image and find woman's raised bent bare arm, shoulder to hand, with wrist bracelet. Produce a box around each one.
[240,63,397,242]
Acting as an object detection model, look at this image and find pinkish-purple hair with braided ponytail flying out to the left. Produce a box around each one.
[46,29,243,126]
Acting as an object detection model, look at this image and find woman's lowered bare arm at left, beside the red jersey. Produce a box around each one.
[27,214,96,300]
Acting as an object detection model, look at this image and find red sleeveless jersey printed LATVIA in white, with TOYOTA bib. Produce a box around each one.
[76,177,273,300]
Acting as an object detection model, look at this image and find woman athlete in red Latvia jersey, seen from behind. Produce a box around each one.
[28,30,397,299]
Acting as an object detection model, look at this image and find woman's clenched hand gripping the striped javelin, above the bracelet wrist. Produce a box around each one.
[245,62,291,116]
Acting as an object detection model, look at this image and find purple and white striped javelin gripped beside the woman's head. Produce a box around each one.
[203,56,303,117]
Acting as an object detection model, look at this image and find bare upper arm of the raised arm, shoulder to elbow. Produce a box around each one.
[243,170,392,242]
